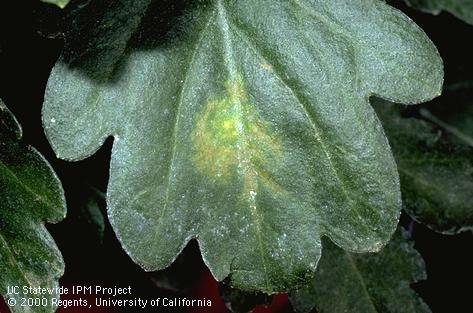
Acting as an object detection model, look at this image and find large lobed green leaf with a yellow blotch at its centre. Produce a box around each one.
[43,0,443,293]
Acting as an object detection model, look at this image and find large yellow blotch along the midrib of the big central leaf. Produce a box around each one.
[192,77,282,194]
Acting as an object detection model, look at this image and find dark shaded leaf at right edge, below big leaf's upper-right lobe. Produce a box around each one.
[375,100,473,234]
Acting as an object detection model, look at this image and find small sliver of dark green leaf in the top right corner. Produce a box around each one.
[404,0,473,24]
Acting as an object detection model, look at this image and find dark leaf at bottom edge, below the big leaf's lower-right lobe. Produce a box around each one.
[290,228,430,313]
